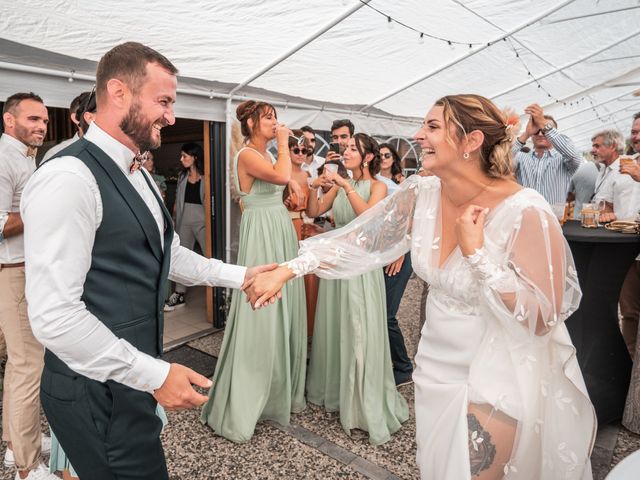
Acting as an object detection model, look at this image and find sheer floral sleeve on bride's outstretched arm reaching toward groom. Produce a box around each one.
[287,175,426,279]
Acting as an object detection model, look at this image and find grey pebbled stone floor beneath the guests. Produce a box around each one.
[0,279,640,480]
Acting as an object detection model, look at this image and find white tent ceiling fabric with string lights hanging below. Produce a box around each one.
[0,0,640,149]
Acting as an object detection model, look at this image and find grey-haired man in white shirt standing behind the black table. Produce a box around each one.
[591,130,635,221]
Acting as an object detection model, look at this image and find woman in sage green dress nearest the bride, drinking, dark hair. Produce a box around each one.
[304,133,409,445]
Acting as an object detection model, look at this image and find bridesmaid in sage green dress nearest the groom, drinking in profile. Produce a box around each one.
[201,100,307,443]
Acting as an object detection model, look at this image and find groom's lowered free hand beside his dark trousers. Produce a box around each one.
[153,363,212,410]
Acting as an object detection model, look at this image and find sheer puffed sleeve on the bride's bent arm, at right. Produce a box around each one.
[467,207,581,340]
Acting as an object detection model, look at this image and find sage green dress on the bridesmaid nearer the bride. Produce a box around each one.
[307,181,409,445]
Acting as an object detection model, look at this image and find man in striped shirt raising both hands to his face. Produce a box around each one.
[512,103,582,205]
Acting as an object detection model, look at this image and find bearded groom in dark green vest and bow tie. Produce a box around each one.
[21,42,274,480]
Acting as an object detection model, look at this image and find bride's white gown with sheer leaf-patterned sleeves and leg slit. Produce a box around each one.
[288,176,596,480]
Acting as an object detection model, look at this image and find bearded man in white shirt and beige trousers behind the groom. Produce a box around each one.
[0,93,56,479]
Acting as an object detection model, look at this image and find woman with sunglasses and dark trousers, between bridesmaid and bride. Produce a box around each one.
[376,143,413,386]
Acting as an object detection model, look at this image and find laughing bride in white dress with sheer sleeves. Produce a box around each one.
[248,95,596,480]
